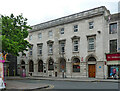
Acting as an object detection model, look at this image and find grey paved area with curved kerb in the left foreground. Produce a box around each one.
[6,80,49,90]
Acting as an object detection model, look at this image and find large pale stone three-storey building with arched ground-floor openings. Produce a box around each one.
[17,6,120,78]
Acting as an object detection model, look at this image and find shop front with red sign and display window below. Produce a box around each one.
[106,53,120,78]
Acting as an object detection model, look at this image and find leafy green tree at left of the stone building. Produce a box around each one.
[1,14,31,56]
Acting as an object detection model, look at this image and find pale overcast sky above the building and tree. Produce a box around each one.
[0,0,120,26]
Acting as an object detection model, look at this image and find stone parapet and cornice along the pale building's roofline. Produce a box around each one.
[29,6,109,32]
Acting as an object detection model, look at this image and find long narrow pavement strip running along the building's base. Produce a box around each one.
[7,77,120,83]
